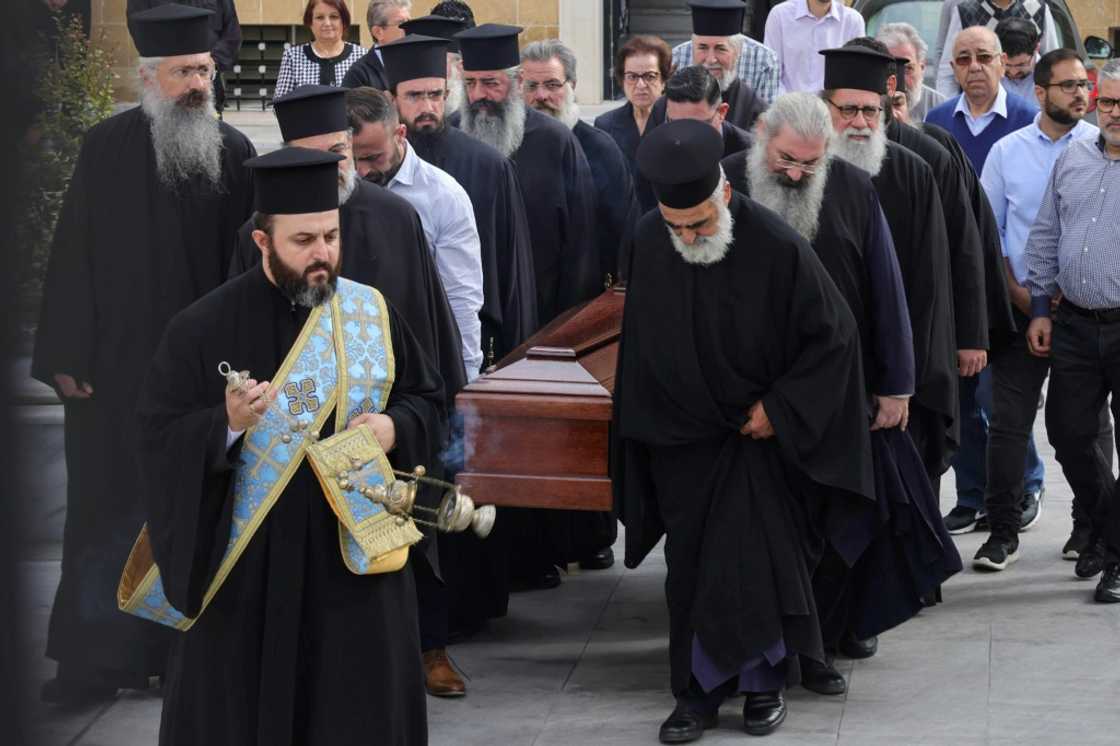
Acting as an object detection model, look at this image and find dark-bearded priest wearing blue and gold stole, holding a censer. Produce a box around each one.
[128,148,445,746]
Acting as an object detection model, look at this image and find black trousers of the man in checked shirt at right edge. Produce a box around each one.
[1046,302,1120,561]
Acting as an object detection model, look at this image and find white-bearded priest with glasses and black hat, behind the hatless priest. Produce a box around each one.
[821,47,959,484]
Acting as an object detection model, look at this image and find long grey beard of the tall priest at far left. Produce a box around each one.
[140,84,222,187]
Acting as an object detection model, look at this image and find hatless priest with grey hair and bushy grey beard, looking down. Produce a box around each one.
[724,93,961,694]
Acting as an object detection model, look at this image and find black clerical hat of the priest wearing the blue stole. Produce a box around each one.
[245,148,343,215]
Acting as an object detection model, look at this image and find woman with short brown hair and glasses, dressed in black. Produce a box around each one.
[595,36,672,213]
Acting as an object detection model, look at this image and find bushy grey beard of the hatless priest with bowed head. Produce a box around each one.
[747,134,829,241]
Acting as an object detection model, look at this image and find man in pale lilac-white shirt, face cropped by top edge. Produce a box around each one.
[763,0,866,93]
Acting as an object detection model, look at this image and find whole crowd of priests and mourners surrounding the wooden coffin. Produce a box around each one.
[32,0,1120,746]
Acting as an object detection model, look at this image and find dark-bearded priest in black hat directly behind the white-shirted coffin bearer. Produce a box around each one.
[382,34,536,365]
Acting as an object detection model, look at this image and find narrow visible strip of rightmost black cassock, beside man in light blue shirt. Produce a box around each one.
[921,122,1019,349]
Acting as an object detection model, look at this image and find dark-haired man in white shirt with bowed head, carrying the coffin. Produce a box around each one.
[346,88,483,379]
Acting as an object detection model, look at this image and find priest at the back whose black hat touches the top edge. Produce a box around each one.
[689,0,766,128]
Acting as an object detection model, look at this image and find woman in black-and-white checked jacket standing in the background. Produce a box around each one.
[272,0,365,99]
